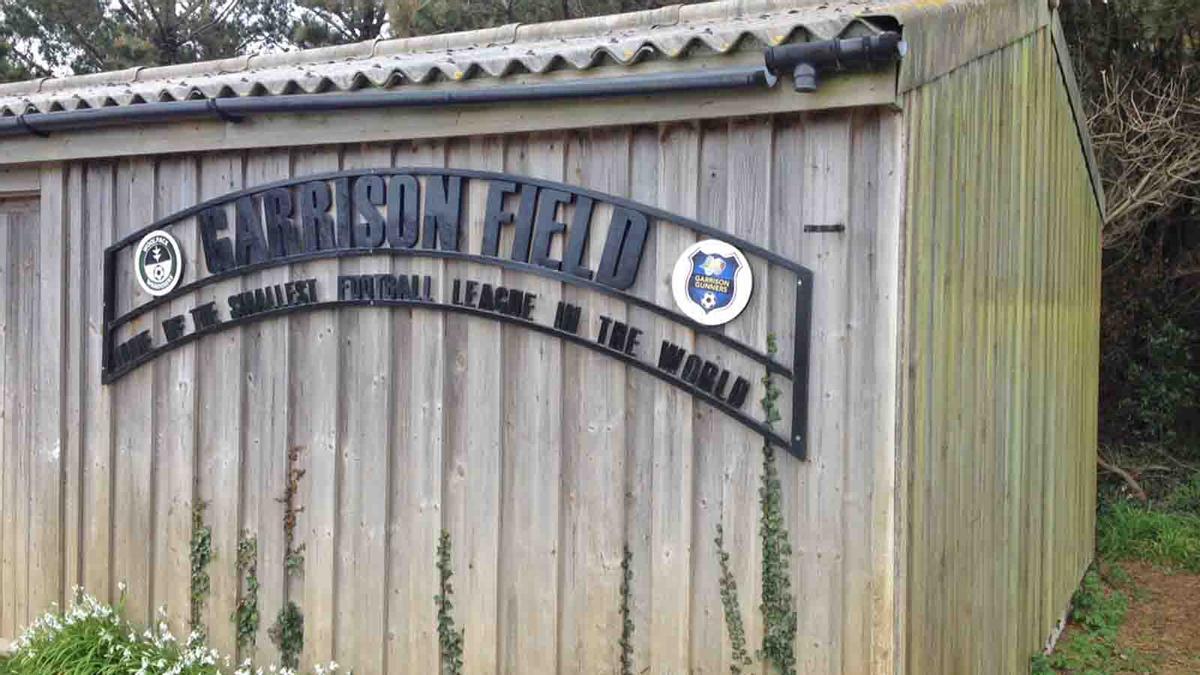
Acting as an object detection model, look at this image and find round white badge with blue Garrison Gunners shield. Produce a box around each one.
[671,239,754,325]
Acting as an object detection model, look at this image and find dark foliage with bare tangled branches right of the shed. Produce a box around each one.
[1062,0,1200,473]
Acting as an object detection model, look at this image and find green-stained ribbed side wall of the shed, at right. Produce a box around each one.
[900,24,1100,674]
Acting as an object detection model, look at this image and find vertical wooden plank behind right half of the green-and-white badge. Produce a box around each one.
[152,157,199,635]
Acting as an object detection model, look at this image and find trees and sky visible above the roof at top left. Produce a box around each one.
[0,0,694,82]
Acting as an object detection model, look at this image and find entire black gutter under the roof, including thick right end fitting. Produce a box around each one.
[0,31,905,138]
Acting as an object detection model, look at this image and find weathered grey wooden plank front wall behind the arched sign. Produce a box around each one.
[0,109,902,675]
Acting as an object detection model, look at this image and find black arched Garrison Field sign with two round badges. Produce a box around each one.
[103,168,811,458]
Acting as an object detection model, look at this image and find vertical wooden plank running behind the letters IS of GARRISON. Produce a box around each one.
[337,145,395,675]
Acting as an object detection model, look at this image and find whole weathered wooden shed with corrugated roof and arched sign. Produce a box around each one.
[0,0,1103,675]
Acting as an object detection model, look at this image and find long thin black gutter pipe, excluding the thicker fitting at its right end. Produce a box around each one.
[0,66,776,138]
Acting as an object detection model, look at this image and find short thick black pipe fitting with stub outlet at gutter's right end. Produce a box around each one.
[764,31,907,92]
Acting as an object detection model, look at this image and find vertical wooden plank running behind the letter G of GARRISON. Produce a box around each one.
[195,153,245,653]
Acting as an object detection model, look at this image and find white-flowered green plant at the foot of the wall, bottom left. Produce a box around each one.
[0,590,337,675]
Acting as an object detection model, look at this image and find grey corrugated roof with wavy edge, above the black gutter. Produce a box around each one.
[0,0,902,117]
